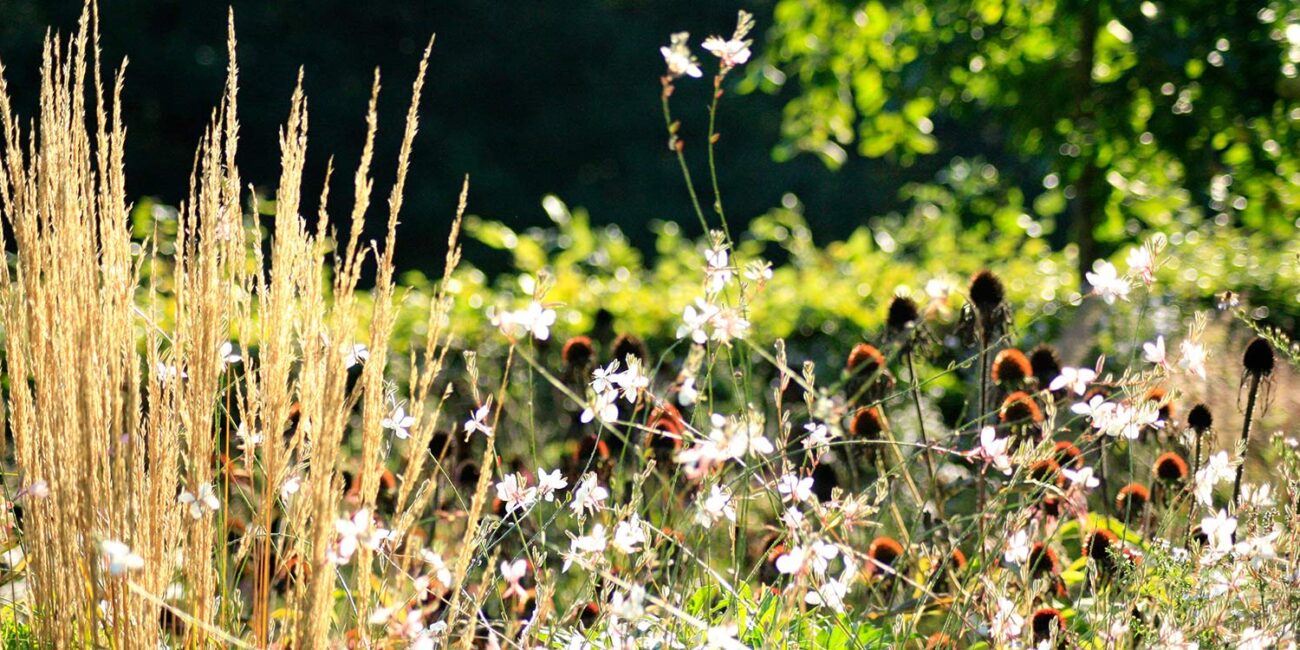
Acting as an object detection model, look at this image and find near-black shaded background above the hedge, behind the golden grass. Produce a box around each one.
[0,0,961,270]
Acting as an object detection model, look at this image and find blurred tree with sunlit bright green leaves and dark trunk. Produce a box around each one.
[748,0,1300,270]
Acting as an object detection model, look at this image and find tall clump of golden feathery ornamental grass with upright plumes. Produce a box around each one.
[0,7,463,647]
